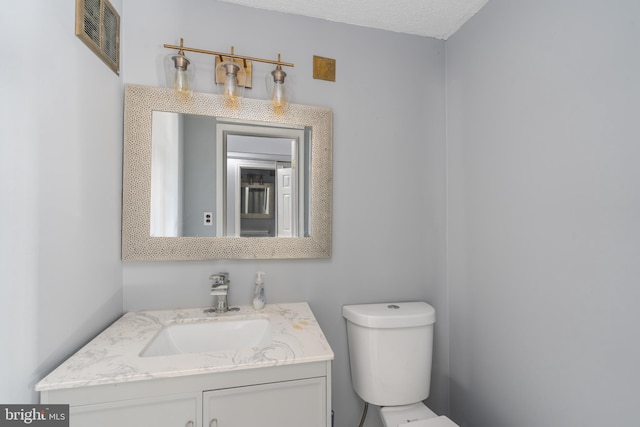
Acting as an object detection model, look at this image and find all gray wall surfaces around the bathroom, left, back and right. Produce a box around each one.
[8,0,640,427]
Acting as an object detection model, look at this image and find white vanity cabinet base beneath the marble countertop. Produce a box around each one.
[41,361,331,427]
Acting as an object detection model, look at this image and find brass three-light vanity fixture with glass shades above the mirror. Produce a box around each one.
[164,39,294,113]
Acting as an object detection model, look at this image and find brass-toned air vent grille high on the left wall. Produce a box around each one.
[76,0,120,74]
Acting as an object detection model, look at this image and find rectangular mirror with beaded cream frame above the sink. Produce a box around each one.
[122,85,332,260]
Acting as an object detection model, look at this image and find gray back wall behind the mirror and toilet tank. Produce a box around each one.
[123,0,448,427]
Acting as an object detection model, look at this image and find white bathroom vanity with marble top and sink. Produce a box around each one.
[36,303,333,427]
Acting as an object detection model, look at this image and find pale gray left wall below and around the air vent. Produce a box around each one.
[0,0,122,403]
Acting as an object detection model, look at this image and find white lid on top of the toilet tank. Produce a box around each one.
[342,302,436,328]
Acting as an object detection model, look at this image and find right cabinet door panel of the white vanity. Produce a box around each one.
[203,378,327,427]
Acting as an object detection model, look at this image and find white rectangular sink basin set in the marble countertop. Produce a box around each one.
[140,318,271,357]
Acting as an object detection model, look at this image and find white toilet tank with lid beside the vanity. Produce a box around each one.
[342,302,436,406]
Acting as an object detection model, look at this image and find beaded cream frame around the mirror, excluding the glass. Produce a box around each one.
[122,85,333,261]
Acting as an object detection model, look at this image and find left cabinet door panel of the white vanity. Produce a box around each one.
[69,393,201,427]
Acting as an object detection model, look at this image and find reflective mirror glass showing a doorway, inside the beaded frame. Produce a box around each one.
[150,111,311,237]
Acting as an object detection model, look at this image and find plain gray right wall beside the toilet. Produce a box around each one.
[447,0,640,427]
